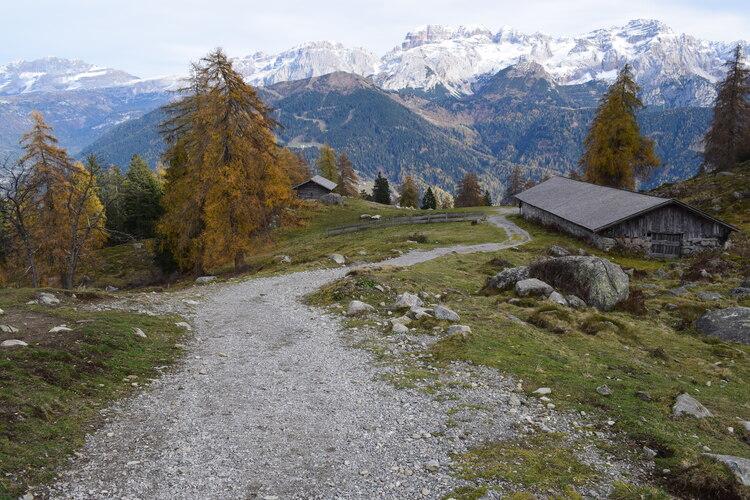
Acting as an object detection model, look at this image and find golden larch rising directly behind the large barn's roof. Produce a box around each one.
[580,64,659,189]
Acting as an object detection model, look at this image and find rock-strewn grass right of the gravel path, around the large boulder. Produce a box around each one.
[311,217,750,498]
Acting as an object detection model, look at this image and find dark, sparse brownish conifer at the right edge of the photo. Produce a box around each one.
[702,44,750,171]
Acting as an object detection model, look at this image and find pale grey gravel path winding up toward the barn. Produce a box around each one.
[38,214,644,500]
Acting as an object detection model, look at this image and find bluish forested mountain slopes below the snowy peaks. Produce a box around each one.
[80,64,710,199]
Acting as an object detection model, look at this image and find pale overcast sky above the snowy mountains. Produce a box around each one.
[0,0,750,77]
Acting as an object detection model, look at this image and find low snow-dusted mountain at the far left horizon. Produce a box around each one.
[0,57,138,95]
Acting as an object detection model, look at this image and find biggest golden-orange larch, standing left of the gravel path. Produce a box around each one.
[157,49,292,274]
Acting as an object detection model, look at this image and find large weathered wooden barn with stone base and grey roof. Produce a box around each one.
[516,177,738,258]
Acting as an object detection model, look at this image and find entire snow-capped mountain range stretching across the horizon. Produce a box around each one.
[0,20,748,107]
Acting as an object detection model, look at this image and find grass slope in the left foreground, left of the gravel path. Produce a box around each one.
[0,290,184,499]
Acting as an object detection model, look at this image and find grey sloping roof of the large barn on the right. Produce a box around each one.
[516,177,738,233]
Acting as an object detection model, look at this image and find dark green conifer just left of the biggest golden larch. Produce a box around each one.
[122,155,164,239]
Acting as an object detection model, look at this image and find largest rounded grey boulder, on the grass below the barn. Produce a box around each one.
[529,255,630,311]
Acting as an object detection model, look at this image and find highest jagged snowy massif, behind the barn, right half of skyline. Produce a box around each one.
[376,20,748,106]
